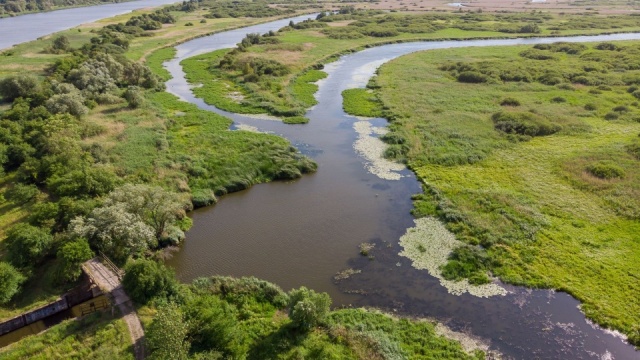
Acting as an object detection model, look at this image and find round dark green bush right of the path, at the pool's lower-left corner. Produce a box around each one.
[122,259,177,304]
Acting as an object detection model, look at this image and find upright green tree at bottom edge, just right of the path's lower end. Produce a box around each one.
[145,303,191,360]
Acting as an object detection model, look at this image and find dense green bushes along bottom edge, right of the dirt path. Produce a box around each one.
[132,277,484,359]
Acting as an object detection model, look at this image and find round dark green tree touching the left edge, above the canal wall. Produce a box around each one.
[5,224,53,267]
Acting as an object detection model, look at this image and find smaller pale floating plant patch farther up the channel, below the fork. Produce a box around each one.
[353,121,404,180]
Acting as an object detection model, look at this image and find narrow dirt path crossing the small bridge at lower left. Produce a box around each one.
[82,258,145,360]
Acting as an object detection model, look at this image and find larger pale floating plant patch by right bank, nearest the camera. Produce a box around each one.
[400,217,507,297]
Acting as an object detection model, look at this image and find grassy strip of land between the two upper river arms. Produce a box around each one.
[183,10,640,118]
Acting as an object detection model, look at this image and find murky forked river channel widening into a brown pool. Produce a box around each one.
[165,21,640,359]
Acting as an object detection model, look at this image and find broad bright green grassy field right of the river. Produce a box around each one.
[376,42,640,344]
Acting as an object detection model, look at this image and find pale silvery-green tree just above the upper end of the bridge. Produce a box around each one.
[69,204,157,262]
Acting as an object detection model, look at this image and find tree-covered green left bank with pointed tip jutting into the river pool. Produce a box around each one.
[0,2,315,318]
